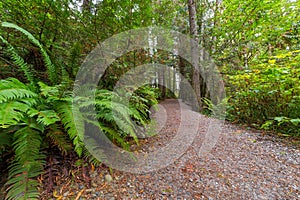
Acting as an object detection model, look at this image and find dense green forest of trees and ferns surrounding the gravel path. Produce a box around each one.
[0,0,300,199]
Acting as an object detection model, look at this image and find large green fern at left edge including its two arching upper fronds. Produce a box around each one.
[0,23,82,199]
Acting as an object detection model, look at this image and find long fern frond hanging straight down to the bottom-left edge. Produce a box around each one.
[6,126,44,200]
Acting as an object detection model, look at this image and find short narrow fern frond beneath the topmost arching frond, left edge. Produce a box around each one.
[0,36,35,86]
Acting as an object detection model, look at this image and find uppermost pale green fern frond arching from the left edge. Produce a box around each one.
[2,22,58,84]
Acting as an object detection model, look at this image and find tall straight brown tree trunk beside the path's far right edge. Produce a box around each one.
[188,0,202,111]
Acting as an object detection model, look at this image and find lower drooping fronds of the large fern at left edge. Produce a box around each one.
[0,78,91,199]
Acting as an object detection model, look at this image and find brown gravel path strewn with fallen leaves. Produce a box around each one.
[37,100,300,200]
